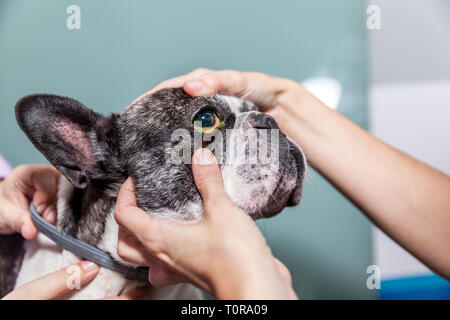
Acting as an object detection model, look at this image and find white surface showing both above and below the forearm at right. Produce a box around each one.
[370,80,450,279]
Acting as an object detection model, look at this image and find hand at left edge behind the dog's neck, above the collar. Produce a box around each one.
[0,164,61,239]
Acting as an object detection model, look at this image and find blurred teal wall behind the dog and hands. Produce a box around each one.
[0,0,374,299]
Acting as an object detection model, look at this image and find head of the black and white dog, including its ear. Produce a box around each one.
[16,88,306,219]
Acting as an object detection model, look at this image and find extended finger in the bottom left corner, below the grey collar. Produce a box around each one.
[4,261,99,300]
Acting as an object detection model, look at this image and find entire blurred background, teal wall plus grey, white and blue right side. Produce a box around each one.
[0,0,450,299]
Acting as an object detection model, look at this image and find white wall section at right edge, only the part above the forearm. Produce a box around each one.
[369,80,450,174]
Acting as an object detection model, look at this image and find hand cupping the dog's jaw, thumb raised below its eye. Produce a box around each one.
[115,149,296,299]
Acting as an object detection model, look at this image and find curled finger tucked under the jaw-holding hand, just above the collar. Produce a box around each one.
[117,227,148,266]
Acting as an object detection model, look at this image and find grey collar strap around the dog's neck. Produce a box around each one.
[30,202,149,282]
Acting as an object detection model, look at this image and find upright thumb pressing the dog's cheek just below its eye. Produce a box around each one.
[192,149,230,213]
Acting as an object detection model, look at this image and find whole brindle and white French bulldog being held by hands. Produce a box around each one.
[0,88,306,299]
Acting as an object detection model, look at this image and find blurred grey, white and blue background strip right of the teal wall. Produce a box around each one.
[368,0,450,299]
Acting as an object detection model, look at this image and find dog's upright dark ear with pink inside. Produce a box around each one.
[16,94,110,188]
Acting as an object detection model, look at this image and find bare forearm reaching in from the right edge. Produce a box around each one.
[276,87,450,278]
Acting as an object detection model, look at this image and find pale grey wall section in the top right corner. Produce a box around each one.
[366,0,450,83]
